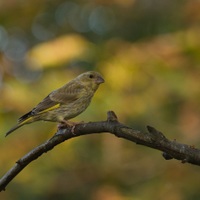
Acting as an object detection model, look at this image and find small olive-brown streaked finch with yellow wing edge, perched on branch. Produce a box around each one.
[5,71,105,136]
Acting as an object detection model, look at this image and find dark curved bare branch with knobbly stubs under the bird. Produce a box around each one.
[0,111,200,191]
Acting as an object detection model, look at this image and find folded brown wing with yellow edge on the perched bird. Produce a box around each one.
[32,82,83,114]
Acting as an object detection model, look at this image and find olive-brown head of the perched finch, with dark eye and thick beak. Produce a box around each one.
[78,71,105,90]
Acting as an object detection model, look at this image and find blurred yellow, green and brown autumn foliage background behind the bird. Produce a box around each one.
[0,0,200,200]
